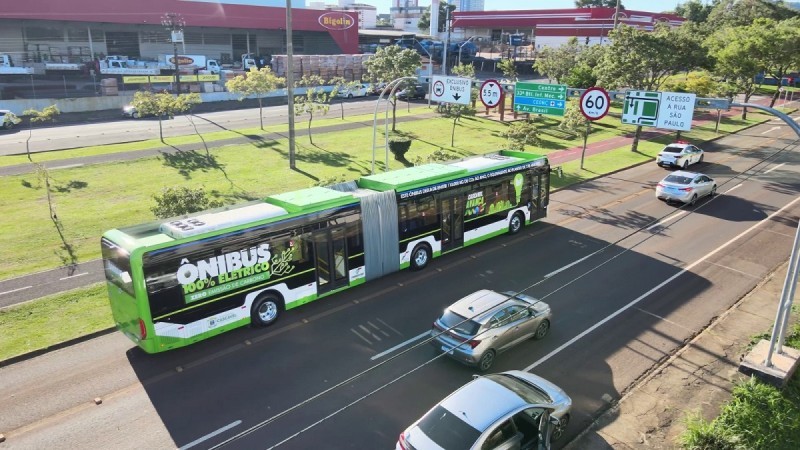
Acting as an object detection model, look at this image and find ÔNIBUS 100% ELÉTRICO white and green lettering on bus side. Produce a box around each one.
[175,243,272,303]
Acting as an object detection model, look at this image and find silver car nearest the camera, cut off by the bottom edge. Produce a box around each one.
[395,370,572,450]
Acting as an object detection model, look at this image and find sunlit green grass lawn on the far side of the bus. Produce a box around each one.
[0,103,769,360]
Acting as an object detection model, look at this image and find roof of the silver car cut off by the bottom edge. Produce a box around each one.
[440,377,528,432]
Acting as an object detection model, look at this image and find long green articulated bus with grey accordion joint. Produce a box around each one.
[101,150,550,353]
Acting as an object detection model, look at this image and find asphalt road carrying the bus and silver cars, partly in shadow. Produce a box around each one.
[0,118,800,449]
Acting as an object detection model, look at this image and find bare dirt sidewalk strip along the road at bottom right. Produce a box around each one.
[565,262,788,450]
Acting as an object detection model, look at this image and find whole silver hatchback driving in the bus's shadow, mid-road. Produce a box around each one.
[430,289,553,372]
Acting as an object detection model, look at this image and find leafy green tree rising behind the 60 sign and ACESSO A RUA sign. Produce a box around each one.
[595,24,707,151]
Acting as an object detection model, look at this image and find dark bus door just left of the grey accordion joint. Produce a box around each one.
[313,228,350,294]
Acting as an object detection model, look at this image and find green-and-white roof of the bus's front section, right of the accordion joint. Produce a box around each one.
[358,150,546,192]
